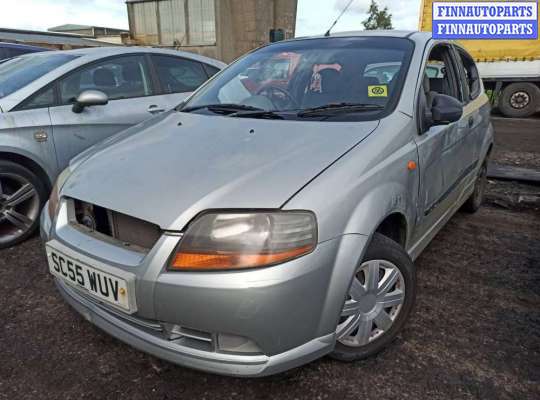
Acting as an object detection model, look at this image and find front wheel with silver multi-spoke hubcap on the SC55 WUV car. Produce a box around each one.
[330,233,416,361]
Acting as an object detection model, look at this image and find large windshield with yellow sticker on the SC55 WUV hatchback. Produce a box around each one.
[181,37,414,120]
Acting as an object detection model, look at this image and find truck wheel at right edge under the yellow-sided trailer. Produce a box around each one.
[499,82,540,118]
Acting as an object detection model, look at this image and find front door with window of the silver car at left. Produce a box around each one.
[50,54,167,168]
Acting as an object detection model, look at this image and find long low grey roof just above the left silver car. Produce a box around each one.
[0,28,118,47]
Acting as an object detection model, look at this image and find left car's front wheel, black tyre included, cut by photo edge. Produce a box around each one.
[0,160,47,249]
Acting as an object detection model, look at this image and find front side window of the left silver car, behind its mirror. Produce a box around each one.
[59,56,153,104]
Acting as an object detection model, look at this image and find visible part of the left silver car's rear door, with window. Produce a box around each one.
[150,54,216,108]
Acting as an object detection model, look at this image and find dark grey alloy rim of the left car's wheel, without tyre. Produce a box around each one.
[0,173,40,245]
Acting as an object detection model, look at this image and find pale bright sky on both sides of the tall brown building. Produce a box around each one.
[0,0,420,36]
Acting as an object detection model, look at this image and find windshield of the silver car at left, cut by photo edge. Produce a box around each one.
[0,53,76,99]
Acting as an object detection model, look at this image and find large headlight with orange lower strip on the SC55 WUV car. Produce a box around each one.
[170,211,317,271]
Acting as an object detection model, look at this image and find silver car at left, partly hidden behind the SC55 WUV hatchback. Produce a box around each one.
[0,47,225,248]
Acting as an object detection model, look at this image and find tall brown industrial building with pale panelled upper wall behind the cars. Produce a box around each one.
[127,0,297,62]
